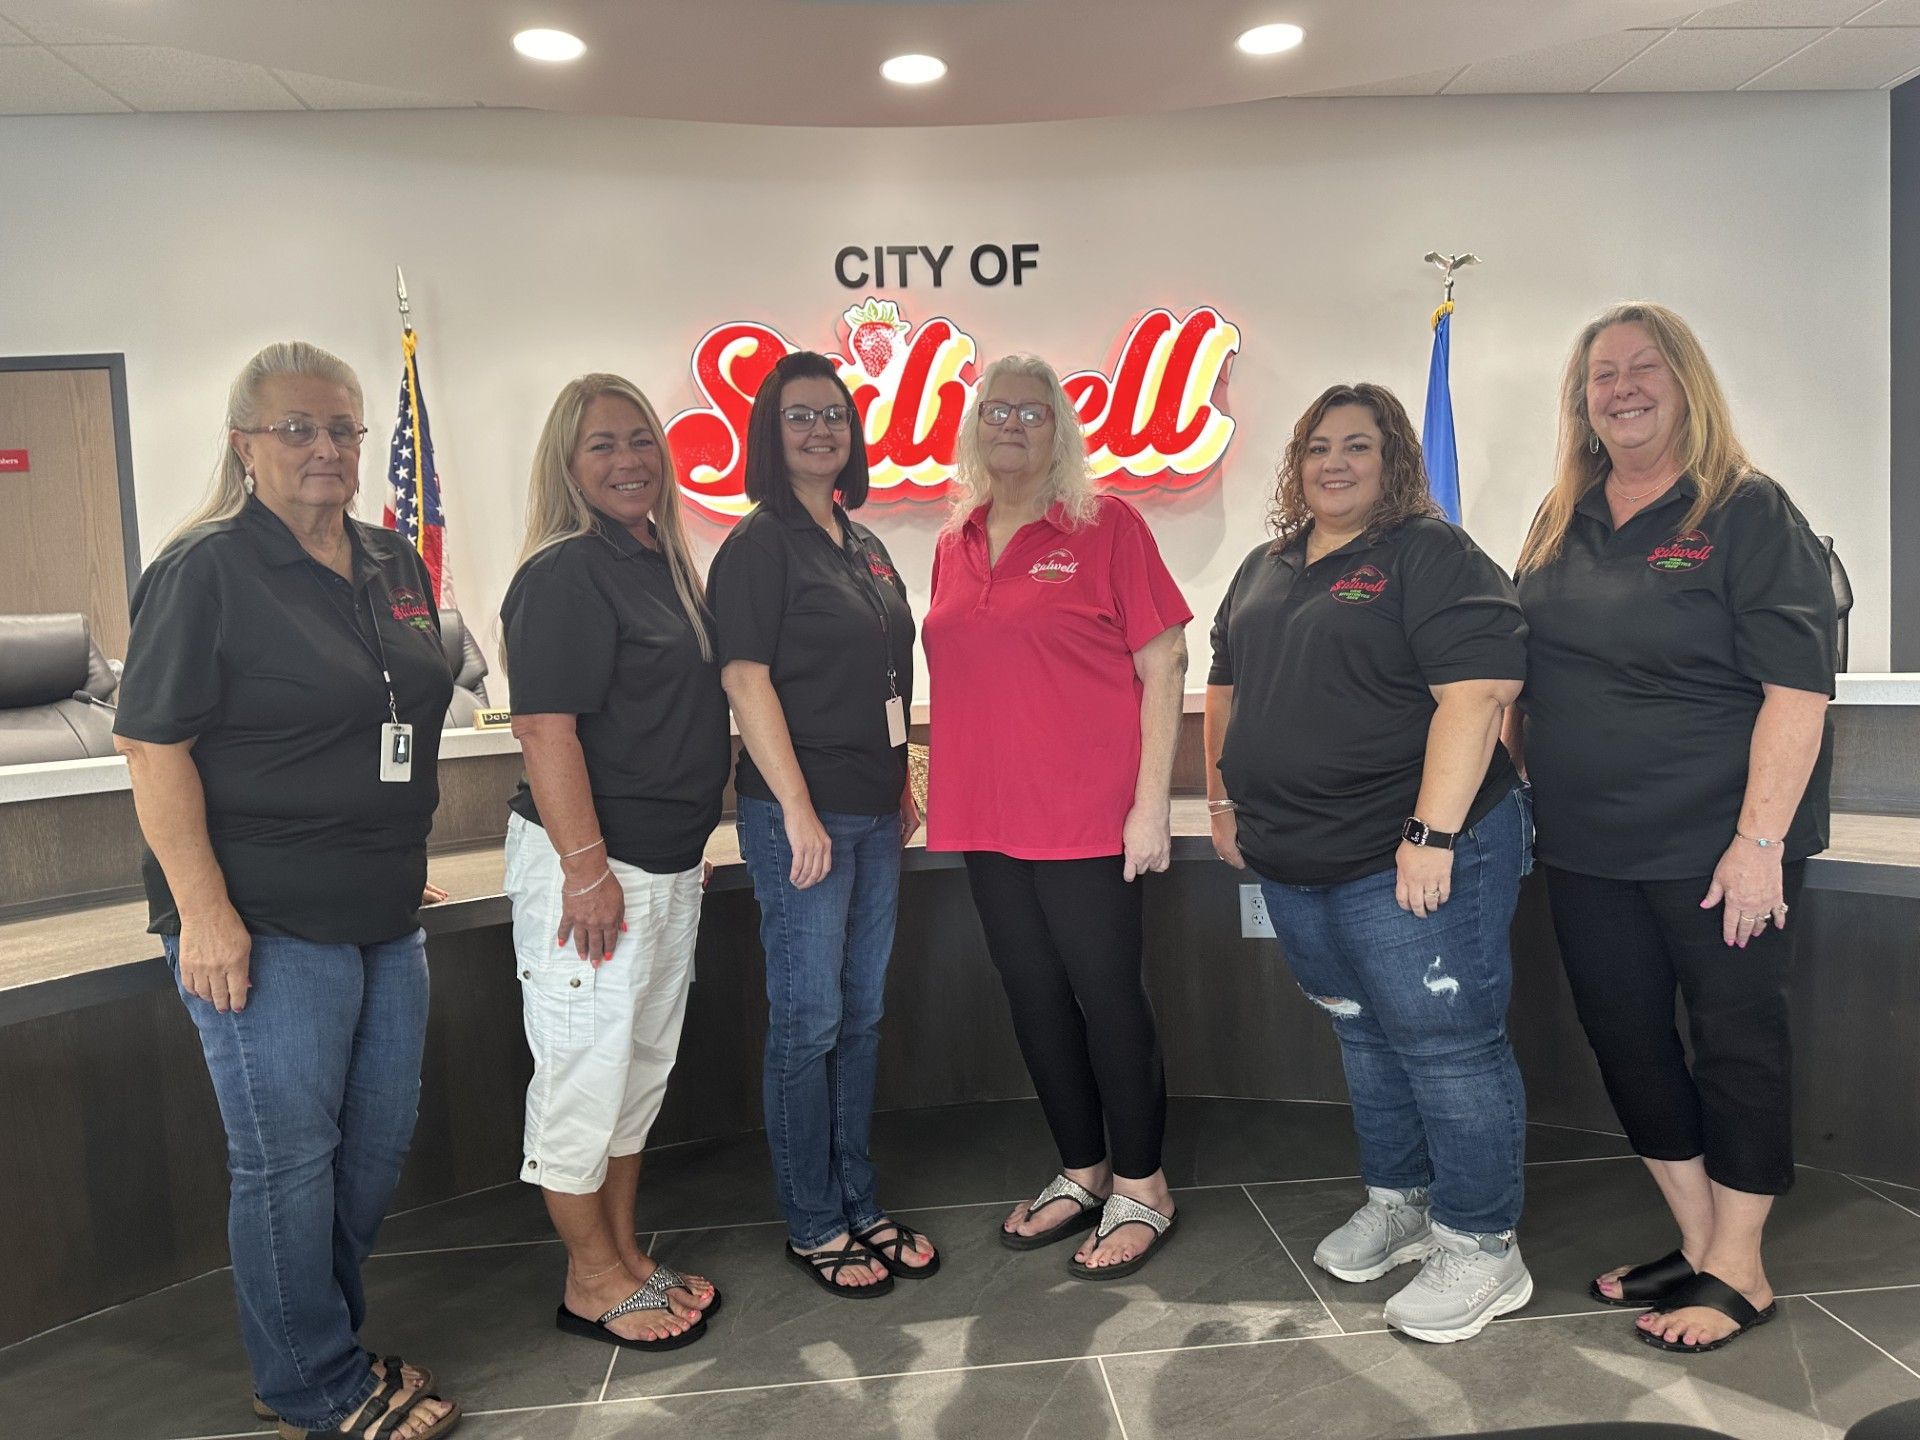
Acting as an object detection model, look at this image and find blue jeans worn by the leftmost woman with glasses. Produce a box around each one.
[165,931,426,1430]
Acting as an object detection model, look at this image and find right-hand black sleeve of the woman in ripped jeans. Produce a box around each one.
[1402,528,1526,685]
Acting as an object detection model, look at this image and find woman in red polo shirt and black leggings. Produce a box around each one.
[922,355,1192,1281]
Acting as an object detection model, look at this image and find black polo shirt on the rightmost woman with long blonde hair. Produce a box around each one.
[1519,476,1836,879]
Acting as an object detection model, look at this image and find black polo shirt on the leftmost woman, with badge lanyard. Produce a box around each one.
[113,499,453,945]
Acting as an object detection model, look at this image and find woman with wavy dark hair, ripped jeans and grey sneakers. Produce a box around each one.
[1206,384,1534,1342]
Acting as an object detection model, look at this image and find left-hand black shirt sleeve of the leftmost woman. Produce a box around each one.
[113,545,225,745]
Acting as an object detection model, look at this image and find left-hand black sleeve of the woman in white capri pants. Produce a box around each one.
[499,555,620,714]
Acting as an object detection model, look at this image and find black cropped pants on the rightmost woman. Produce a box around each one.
[1542,860,1807,1194]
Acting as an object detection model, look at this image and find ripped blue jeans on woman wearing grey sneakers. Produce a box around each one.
[1261,789,1532,1235]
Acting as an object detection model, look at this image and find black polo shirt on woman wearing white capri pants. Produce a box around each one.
[499,515,732,876]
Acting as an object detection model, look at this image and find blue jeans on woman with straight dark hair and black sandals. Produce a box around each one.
[739,795,900,1250]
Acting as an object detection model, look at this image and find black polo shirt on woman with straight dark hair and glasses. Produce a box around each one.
[707,505,914,814]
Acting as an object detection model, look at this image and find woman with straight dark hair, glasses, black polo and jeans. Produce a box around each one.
[707,351,939,1300]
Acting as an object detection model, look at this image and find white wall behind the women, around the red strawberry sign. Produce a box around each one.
[0,92,1889,685]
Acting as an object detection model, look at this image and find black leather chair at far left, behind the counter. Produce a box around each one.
[0,614,119,764]
